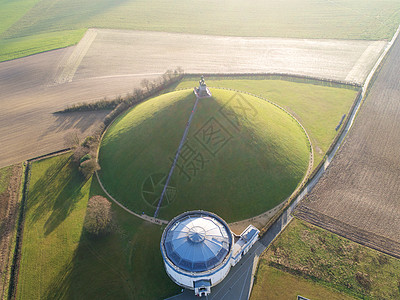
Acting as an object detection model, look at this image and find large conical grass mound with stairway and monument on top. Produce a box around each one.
[99,89,309,222]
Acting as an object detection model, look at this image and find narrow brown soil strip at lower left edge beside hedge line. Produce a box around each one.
[0,165,22,299]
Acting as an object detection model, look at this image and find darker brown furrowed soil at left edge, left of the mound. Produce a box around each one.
[0,47,153,167]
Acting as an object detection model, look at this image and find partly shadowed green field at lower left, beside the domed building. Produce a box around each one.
[17,155,179,299]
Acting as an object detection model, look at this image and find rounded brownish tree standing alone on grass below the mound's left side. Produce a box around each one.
[83,196,113,236]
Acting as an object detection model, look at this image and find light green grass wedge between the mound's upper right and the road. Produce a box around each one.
[176,77,357,167]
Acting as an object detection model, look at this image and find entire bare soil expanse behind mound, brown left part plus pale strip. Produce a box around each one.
[0,29,386,167]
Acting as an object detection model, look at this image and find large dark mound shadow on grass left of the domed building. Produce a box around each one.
[43,181,179,299]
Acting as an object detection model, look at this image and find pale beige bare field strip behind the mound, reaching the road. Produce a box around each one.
[70,29,386,83]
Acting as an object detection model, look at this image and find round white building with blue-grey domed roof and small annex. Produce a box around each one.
[160,211,259,296]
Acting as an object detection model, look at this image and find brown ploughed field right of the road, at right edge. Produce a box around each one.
[296,33,400,257]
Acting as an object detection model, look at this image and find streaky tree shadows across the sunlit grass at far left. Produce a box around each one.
[27,156,85,235]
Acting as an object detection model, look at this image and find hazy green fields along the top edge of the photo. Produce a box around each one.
[0,0,400,61]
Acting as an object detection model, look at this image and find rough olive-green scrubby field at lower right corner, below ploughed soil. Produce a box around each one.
[251,219,400,300]
